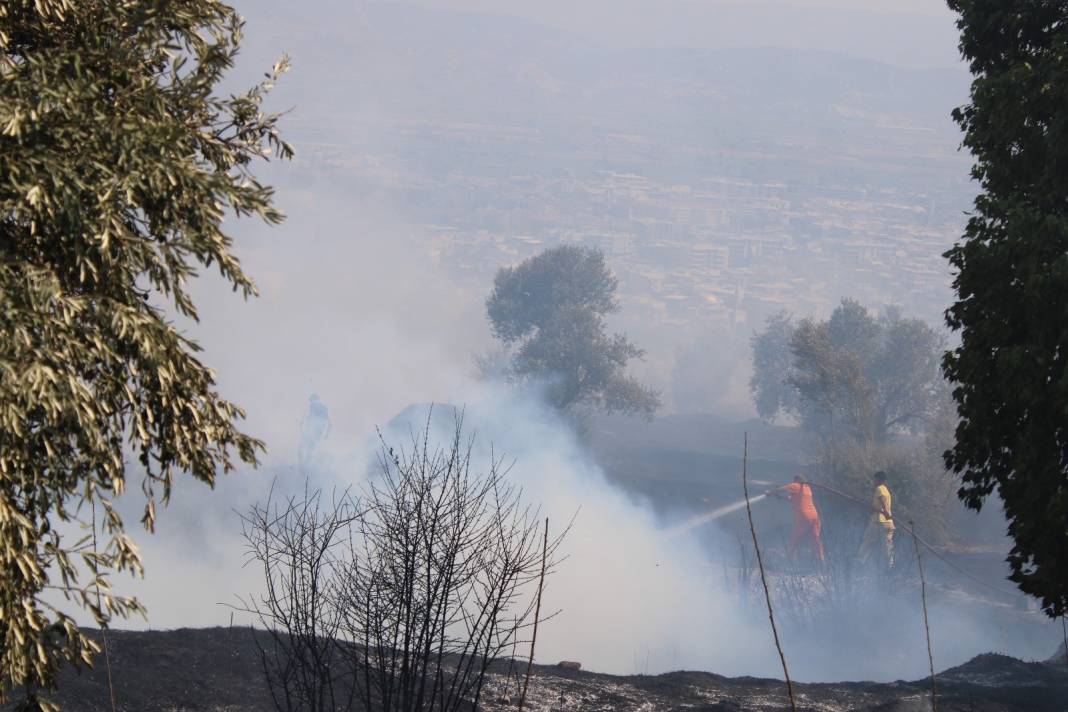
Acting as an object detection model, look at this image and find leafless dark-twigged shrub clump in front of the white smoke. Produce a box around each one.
[237,418,566,712]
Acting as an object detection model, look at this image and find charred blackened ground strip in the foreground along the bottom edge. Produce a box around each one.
[0,628,1068,712]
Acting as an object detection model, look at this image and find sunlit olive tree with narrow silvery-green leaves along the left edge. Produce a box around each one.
[0,0,290,709]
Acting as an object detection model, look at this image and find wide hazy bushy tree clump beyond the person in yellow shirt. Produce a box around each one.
[750,299,943,443]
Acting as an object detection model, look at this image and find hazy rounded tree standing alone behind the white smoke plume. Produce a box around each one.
[486,246,660,417]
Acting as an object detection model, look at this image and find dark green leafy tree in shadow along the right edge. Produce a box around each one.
[944,0,1068,616]
